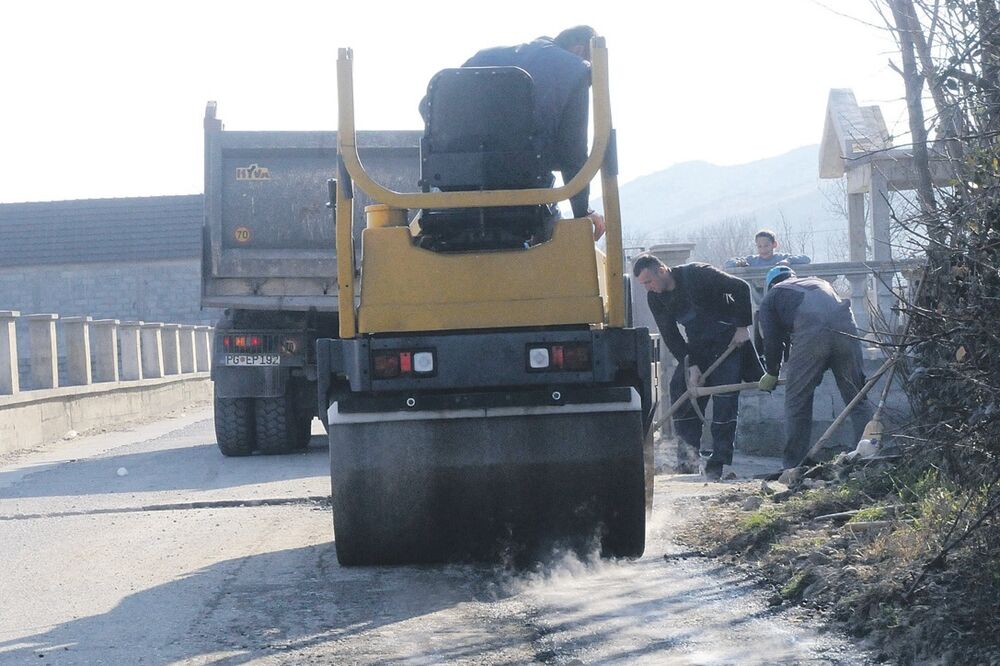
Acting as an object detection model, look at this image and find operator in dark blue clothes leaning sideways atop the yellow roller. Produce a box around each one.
[421,25,605,241]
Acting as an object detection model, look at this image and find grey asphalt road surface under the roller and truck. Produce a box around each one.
[0,408,865,664]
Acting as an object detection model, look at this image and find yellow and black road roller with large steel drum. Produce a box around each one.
[316,40,657,565]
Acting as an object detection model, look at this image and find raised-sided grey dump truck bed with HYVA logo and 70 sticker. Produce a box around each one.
[202,106,420,311]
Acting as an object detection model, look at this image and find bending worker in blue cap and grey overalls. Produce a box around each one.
[758,266,872,469]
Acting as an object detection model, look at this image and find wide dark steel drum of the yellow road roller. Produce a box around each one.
[328,390,646,565]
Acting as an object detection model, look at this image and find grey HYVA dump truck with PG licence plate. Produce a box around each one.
[201,102,420,456]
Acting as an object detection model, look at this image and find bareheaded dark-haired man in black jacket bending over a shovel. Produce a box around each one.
[632,255,759,480]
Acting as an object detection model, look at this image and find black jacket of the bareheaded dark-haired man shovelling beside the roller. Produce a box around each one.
[646,262,753,370]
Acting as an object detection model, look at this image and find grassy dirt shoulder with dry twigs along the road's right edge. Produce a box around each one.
[676,448,1000,664]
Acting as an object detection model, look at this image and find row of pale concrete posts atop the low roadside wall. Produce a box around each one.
[0,310,212,396]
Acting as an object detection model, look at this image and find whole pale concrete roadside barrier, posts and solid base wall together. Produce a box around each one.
[0,310,213,453]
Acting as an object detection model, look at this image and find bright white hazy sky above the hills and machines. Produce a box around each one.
[0,0,906,202]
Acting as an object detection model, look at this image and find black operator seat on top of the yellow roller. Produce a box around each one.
[419,67,552,251]
